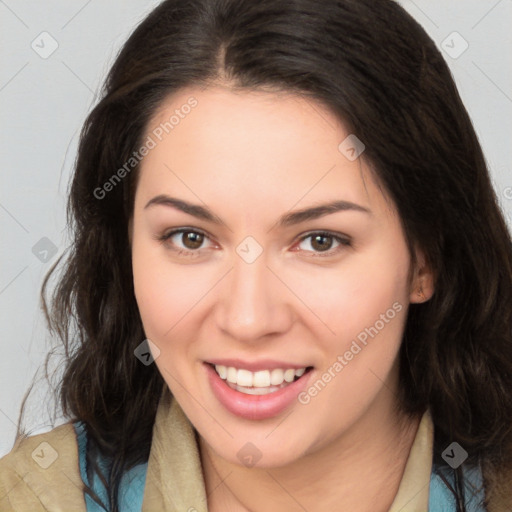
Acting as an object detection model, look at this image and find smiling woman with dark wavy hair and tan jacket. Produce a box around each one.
[0,0,512,512]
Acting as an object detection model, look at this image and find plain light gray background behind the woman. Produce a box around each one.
[0,0,512,456]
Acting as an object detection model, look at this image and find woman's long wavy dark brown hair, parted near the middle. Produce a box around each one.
[18,0,512,512]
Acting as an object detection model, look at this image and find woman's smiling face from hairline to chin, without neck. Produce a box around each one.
[130,86,426,467]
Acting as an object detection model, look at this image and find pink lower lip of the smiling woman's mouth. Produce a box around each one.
[204,363,312,420]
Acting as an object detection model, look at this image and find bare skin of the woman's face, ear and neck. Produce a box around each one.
[130,84,433,512]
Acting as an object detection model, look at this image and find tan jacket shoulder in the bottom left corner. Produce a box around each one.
[0,422,86,512]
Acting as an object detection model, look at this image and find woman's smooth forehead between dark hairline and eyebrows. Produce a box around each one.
[135,86,392,218]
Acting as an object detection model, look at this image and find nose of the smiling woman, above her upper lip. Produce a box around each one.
[217,252,293,343]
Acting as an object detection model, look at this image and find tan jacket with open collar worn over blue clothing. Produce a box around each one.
[0,387,512,512]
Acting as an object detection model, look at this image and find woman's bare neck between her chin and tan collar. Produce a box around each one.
[199,389,421,512]
